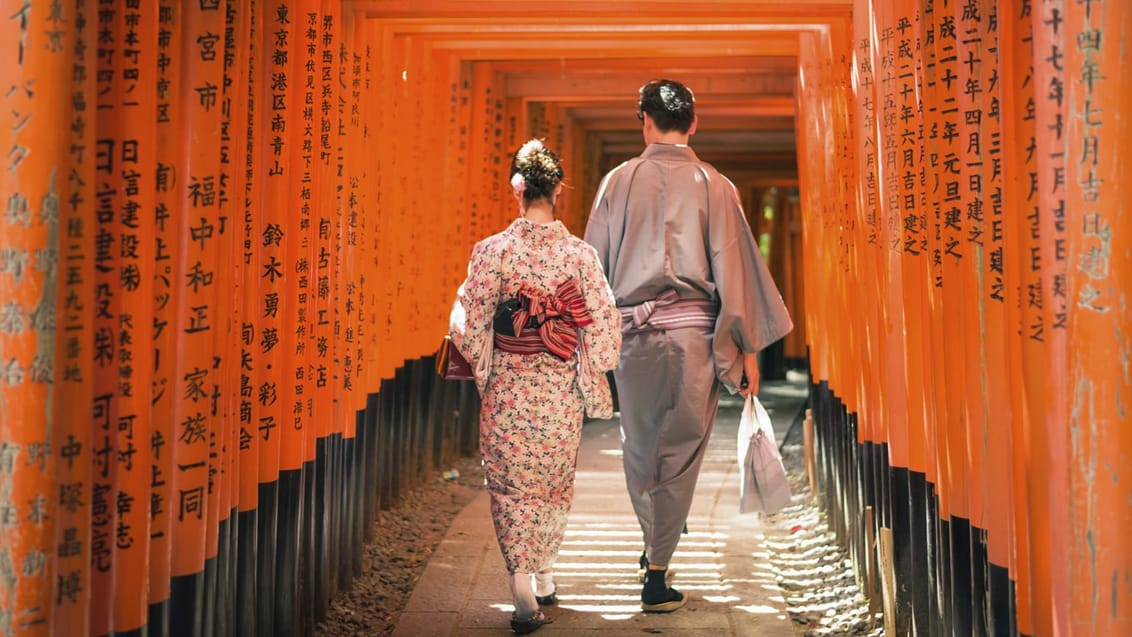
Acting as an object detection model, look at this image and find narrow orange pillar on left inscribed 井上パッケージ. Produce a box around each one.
[149,0,187,631]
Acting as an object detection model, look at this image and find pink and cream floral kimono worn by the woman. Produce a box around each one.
[452,218,621,574]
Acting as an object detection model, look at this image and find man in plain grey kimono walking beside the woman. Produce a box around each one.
[585,79,794,612]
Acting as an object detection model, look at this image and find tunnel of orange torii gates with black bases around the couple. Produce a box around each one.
[0,0,1132,636]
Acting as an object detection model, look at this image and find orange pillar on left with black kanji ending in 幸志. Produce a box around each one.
[106,1,158,632]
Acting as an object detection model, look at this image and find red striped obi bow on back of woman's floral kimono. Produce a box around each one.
[495,278,593,361]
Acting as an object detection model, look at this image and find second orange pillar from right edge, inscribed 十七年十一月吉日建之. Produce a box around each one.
[1022,0,1071,635]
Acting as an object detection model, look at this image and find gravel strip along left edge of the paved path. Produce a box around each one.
[315,456,483,637]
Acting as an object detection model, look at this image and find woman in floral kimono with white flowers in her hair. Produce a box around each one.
[452,139,621,634]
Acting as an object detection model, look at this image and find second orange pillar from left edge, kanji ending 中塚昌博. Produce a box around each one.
[53,0,95,635]
